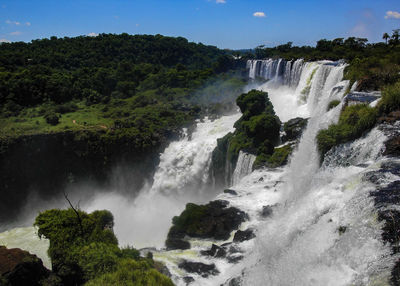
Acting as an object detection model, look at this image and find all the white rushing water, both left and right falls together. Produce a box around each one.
[0,59,394,286]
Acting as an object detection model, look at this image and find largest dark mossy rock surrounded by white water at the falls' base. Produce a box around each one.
[166,200,247,249]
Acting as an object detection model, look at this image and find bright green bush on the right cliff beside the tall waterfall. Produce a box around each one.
[317,104,378,158]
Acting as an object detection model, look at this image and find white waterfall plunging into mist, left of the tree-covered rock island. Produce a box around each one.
[84,112,241,248]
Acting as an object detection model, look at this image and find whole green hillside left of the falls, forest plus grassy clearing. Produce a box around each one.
[0,34,245,141]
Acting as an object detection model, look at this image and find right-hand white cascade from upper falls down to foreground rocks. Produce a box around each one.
[156,60,394,286]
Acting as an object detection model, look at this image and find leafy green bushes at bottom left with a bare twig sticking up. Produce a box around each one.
[34,208,172,285]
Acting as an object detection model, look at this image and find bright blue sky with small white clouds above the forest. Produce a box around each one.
[0,0,400,49]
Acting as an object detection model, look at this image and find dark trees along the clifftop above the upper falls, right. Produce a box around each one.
[250,30,400,90]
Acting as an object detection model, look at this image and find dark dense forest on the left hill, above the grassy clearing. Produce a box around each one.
[0,34,241,111]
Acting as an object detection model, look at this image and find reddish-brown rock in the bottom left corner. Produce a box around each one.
[0,246,50,286]
